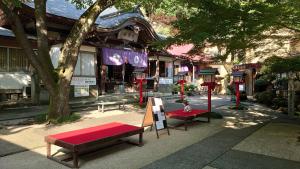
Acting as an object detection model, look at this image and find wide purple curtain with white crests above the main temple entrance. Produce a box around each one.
[102,48,148,67]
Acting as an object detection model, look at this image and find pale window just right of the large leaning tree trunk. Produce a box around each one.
[74,52,95,76]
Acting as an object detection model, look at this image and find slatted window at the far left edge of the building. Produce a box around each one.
[0,47,29,72]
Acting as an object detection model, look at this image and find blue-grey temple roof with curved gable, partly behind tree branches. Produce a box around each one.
[25,0,162,40]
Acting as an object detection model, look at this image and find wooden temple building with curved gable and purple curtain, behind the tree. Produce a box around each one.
[0,0,190,100]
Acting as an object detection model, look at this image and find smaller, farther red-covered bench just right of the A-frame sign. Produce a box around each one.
[166,109,210,130]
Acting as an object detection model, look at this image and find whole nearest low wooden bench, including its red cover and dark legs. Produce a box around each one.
[45,122,144,168]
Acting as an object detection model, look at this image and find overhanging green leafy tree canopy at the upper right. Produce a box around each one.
[161,0,300,58]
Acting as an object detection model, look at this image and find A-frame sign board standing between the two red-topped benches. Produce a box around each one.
[142,97,170,138]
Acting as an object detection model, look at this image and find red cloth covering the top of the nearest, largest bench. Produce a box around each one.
[48,122,141,145]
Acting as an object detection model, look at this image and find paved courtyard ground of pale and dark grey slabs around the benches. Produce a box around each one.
[0,96,300,169]
